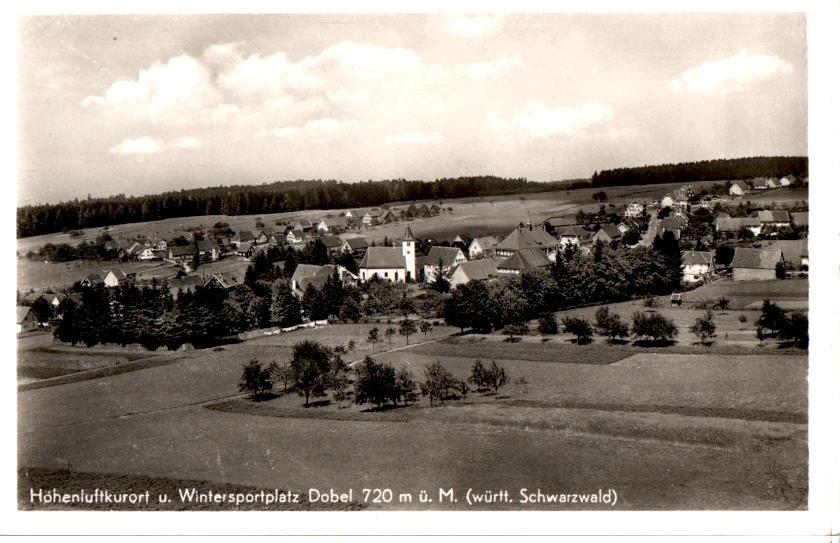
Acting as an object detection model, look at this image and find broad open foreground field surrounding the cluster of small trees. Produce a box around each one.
[18,325,807,509]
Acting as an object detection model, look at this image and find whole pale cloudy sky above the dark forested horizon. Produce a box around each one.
[18,13,807,204]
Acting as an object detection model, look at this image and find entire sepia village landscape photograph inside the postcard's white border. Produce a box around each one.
[4,3,838,535]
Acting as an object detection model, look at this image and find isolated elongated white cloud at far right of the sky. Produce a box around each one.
[667,52,793,94]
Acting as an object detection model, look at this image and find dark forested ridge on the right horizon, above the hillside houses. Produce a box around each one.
[592,156,808,187]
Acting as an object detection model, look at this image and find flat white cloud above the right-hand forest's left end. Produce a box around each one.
[502,101,613,138]
